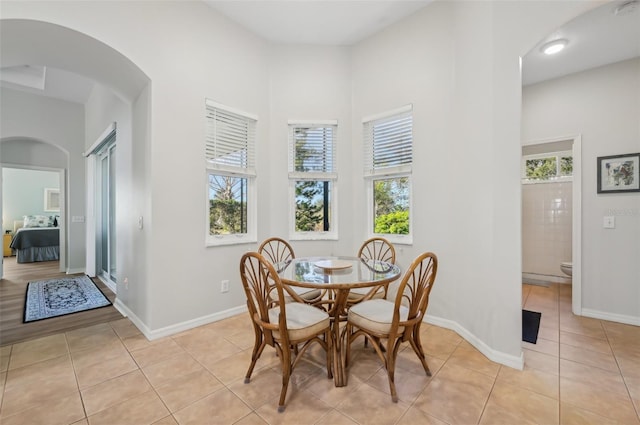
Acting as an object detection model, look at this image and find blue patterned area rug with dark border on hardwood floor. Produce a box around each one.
[24,276,111,323]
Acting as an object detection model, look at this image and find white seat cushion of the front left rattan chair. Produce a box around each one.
[269,302,331,340]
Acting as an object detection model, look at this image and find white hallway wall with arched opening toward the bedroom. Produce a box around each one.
[0,88,85,271]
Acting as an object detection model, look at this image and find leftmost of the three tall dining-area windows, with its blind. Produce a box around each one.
[205,100,257,245]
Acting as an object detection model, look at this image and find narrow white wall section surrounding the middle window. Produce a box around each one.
[268,46,357,257]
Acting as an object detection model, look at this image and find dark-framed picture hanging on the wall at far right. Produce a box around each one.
[598,153,640,193]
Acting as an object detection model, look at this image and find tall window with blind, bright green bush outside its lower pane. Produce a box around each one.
[363,105,413,243]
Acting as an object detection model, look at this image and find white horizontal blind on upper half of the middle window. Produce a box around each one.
[289,123,337,178]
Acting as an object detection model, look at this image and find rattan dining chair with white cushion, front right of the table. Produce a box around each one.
[344,252,438,403]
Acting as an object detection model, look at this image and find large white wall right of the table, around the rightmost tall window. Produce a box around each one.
[353,2,604,365]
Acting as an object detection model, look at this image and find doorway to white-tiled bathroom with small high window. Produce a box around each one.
[521,135,582,315]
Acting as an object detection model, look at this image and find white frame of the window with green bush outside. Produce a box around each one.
[362,104,414,245]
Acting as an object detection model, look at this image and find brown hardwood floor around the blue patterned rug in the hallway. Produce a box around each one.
[0,253,123,346]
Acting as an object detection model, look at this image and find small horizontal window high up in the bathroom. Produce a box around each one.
[522,151,573,183]
